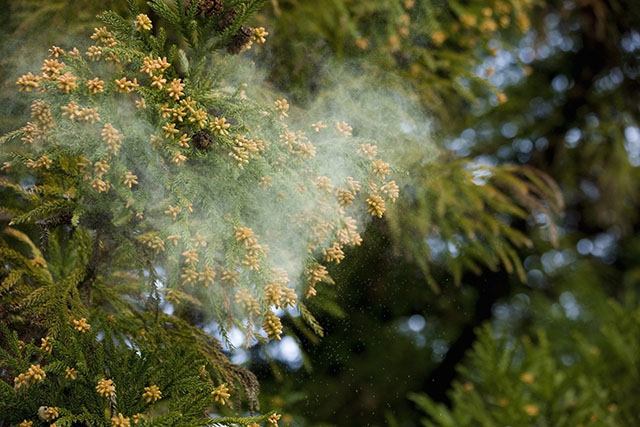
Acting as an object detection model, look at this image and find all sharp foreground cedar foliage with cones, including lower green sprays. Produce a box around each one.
[0,0,398,426]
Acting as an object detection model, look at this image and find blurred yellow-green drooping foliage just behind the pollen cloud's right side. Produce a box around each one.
[255,0,563,291]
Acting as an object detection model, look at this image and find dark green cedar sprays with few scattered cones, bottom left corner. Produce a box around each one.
[0,322,248,426]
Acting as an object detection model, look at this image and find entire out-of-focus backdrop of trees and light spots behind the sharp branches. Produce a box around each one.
[0,0,640,426]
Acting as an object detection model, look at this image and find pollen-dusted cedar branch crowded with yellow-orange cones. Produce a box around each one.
[10,2,398,364]
